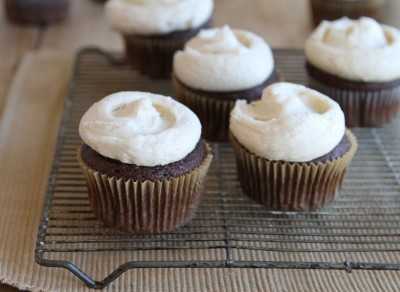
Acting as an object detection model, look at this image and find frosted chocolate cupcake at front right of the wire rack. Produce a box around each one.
[230,83,357,211]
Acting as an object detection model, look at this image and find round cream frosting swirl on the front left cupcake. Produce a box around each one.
[79,92,201,167]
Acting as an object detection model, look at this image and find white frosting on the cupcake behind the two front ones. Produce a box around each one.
[174,26,274,92]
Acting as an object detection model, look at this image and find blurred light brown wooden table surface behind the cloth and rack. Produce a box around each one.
[0,0,400,292]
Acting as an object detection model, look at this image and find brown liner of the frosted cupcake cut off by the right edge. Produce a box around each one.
[309,76,400,127]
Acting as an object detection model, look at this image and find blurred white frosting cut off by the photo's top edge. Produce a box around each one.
[106,0,214,35]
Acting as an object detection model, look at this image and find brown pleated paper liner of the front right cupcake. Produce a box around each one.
[230,131,357,211]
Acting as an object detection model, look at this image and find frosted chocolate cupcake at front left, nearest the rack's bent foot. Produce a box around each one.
[78,92,212,233]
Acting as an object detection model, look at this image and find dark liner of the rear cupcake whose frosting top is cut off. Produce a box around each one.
[123,19,212,79]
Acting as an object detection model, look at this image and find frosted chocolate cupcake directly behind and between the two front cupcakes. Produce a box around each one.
[173,26,277,142]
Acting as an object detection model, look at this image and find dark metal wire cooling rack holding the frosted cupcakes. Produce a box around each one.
[36,48,400,288]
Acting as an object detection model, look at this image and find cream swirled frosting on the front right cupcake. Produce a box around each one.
[230,83,346,162]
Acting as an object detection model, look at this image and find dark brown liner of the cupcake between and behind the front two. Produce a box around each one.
[172,72,281,142]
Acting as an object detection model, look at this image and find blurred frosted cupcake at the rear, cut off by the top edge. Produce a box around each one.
[106,0,214,78]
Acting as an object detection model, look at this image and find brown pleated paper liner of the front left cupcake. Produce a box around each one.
[78,145,212,233]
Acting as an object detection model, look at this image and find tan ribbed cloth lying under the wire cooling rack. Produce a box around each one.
[0,52,400,292]
